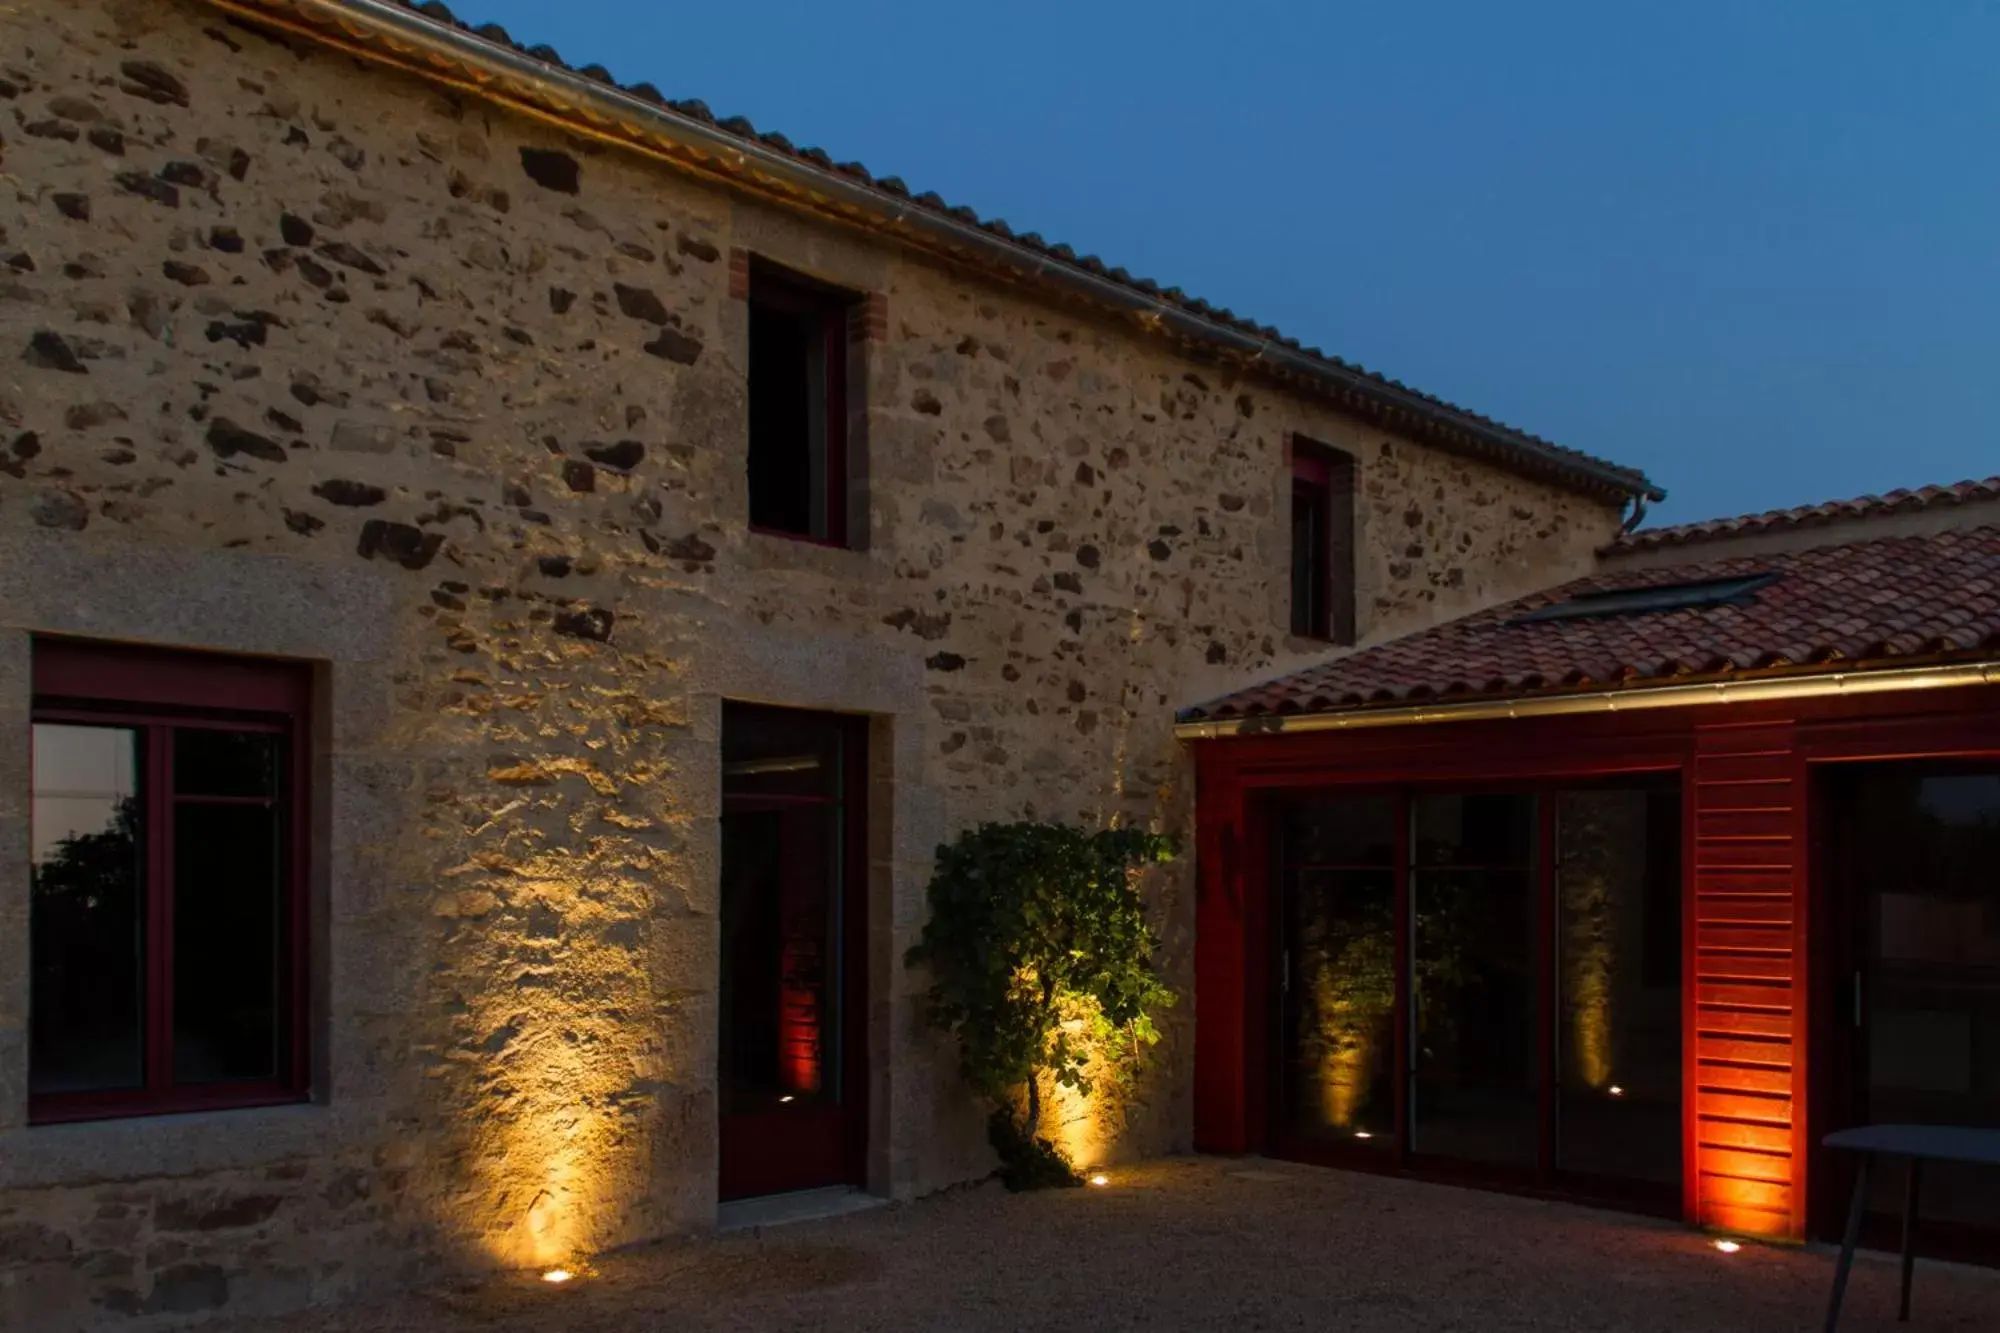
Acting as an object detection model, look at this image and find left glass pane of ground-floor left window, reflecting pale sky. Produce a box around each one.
[28,723,146,1095]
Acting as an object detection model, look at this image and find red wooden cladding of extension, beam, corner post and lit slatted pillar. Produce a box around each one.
[1194,689,2000,1241]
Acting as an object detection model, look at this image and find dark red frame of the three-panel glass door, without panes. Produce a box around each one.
[1256,765,1692,1219]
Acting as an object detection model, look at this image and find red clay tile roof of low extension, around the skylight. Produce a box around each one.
[1182,526,2000,723]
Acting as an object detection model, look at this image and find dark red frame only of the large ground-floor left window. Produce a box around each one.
[28,638,312,1125]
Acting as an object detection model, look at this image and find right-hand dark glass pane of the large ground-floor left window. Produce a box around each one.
[174,801,288,1083]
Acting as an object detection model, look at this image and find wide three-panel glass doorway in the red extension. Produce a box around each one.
[1270,775,1682,1211]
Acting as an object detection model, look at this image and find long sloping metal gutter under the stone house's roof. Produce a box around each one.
[208,0,1666,510]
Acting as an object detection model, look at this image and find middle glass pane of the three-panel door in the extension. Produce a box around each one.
[1410,797,1540,1167]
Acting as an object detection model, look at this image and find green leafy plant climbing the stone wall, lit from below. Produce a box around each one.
[908,823,1174,1189]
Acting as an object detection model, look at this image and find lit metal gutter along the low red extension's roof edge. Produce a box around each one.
[1174,660,2000,741]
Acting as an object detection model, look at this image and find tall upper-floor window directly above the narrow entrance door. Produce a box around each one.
[750,268,854,546]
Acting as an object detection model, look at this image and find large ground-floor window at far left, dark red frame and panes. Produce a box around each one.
[28,638,312,1123]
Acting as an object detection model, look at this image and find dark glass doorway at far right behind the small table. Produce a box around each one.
[1812,763,2000,1263]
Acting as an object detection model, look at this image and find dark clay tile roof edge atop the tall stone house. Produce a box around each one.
[210,0,1666,500]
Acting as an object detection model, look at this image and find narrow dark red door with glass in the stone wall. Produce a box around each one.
[718,703,868,1201]
